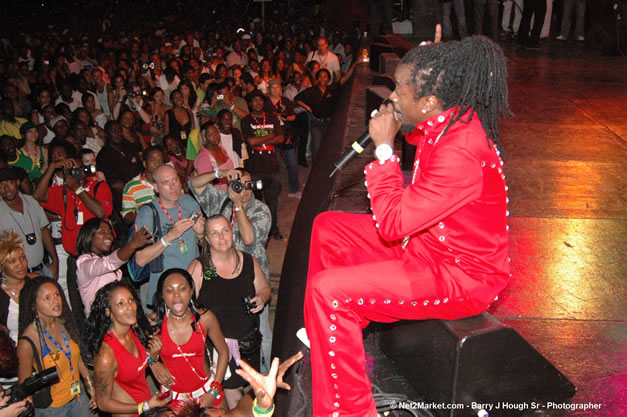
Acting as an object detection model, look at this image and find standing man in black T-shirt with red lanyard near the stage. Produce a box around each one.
[240,91,284,240]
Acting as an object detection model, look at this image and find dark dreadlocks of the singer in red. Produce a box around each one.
[401,36,511,151]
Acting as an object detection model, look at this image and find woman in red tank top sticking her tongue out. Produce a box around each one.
[155,268,229,408]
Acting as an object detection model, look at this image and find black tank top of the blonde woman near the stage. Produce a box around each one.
[198,252,257,339]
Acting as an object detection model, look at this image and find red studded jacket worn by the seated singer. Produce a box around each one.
[366,109,509,305]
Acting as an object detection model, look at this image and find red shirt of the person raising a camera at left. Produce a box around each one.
[39,176,113,256]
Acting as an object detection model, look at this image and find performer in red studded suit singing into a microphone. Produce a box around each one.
[305,37,509,417]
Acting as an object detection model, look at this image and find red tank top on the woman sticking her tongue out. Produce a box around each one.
[161,315,207,393]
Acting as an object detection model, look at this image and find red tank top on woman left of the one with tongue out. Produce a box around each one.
[103,330,150,415]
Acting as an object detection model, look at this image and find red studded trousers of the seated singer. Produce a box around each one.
[305,212,487,417]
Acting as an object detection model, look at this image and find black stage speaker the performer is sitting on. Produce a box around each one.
[377,313,576,417]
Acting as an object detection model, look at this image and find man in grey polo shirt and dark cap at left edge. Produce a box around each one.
[0,167,59,279]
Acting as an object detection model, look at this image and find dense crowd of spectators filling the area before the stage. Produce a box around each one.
[0,2,356,416]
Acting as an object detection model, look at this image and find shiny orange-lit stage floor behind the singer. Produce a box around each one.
[489,41,627,417]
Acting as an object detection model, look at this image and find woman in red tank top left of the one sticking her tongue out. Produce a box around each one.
[87,281,168,417]
